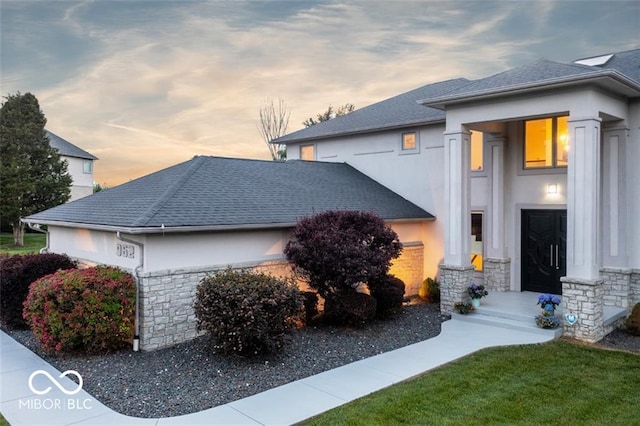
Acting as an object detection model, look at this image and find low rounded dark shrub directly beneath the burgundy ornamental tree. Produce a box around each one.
[324,291,377,327]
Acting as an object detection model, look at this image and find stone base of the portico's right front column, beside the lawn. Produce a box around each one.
[560,277,605,343]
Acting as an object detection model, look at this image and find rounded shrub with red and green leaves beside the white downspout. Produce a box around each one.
[24,266,136,353]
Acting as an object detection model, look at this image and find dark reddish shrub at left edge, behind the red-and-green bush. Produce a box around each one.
[0,253,76,329]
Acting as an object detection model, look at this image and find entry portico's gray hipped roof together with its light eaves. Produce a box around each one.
[420,49,640,108]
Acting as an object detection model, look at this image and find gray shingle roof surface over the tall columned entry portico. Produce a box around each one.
[420,49,640,107]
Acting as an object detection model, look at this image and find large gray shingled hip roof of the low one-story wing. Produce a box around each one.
[25,157,433,233]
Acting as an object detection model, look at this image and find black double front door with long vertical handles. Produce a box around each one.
[521,210,567,294]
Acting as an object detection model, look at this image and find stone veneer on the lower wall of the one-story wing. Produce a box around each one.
[139,244,424,351]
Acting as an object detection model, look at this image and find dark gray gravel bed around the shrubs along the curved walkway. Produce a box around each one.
[5,304,640,417]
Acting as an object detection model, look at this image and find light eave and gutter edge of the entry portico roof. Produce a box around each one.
[418,70,640,110]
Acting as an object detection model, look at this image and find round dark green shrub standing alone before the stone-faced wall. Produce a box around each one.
[194,268,303,356]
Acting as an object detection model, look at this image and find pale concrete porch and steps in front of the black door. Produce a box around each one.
[451,291,627,339]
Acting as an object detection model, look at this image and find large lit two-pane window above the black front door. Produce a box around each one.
[524,116,569,169]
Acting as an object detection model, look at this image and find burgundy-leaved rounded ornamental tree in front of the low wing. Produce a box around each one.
[284,211,402,299]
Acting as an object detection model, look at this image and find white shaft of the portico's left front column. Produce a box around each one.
[444,131,471,266]
